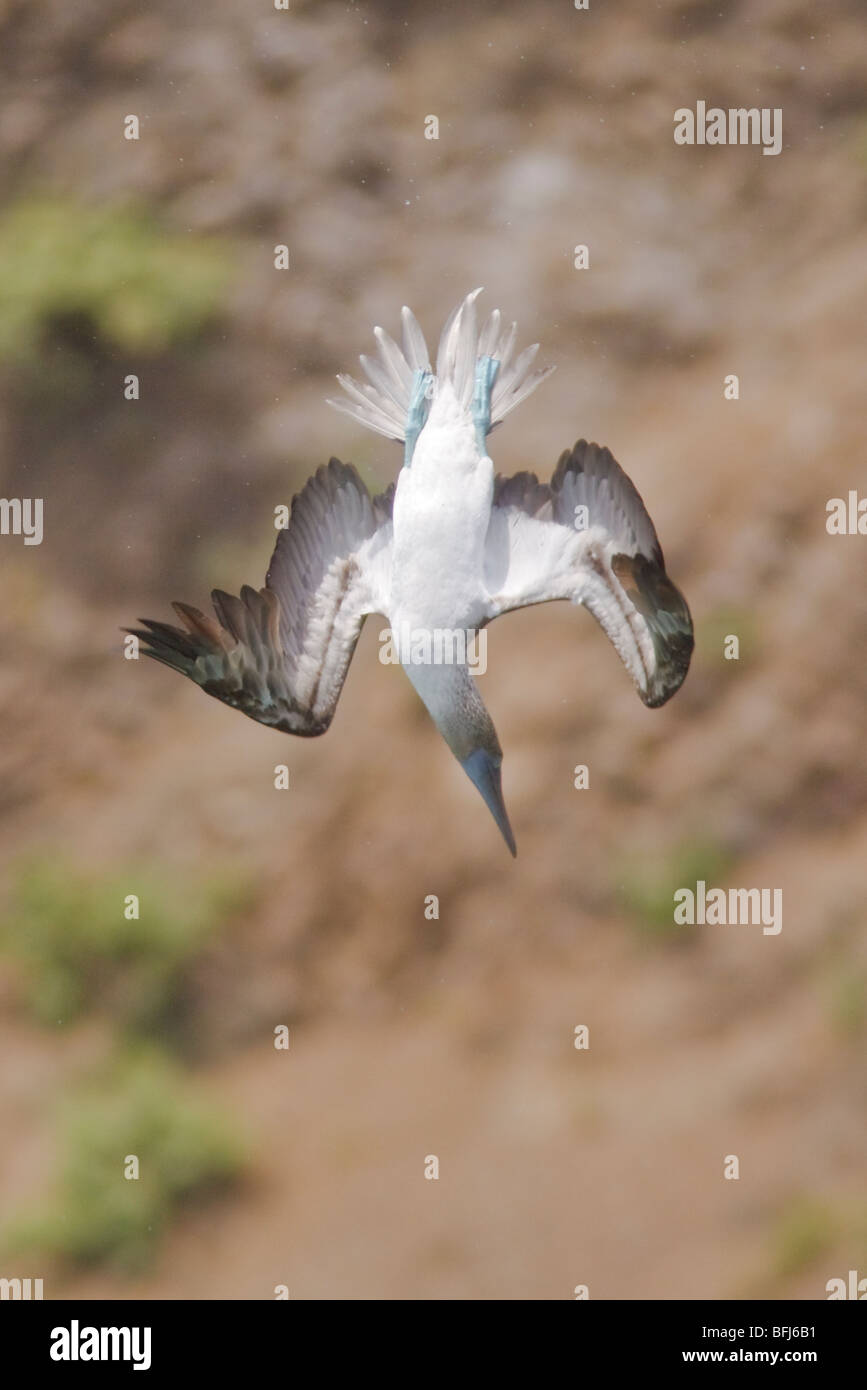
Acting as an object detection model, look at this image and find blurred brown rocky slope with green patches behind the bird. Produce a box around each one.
[0,0,867,1300]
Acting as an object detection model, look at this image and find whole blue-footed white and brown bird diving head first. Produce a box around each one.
[126,289,693,855]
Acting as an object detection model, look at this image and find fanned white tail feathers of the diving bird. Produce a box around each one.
[328,289,554,443]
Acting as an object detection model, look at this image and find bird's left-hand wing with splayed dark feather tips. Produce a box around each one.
[128,459,393,737]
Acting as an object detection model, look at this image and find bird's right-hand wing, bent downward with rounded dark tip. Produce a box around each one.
[485,439,693,708]
